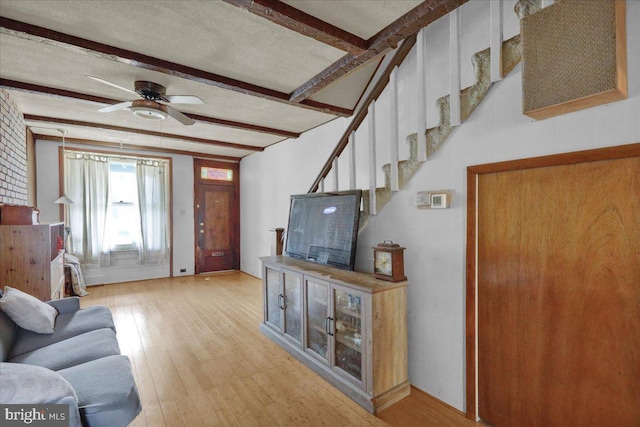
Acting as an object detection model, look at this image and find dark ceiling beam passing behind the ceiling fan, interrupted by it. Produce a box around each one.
[0,79,300,138]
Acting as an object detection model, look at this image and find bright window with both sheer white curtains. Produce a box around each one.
[64,150,170,266]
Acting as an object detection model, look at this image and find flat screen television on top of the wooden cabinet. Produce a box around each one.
[285,190,362,271]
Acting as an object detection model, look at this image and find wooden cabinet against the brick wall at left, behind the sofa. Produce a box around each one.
[0,223,64,301]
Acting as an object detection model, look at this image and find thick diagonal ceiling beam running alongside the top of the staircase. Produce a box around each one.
[290,0,469,102]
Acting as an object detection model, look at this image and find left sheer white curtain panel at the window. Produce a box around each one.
[64,151,109,265]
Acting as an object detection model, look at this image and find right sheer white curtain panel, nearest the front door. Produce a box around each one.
[136,159,169,264]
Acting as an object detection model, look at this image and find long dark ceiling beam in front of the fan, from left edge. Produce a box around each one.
[0,16,352,117]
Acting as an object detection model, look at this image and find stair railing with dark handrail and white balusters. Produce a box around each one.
[309,0,543,228]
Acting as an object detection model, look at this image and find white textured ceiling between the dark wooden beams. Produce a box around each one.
[0,0,456,158]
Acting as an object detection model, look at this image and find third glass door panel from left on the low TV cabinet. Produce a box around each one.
[306,280,330,362]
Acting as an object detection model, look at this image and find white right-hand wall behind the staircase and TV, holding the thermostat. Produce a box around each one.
[240,1,640,410]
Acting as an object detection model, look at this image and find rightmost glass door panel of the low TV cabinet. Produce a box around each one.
[334,289,363,381]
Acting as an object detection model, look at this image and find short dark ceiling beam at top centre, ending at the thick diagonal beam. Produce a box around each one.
[224,0,368,55]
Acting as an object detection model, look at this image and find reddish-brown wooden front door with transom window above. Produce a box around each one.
[194,159,240,273]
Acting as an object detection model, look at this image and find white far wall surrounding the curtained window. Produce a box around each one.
[36,140,195,285]
